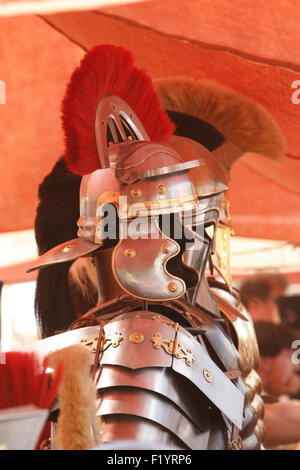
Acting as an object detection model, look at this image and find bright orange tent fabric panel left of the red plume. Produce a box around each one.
[0,16,79,232]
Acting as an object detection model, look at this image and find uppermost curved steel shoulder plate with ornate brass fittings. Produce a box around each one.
[101,312,244,429]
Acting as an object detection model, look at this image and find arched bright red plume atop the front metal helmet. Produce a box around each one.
[62,45,174,175]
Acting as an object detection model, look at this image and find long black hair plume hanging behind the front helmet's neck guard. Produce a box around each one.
[35,158,98,337]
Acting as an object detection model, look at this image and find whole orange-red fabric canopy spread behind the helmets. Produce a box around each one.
[0,0,300,243]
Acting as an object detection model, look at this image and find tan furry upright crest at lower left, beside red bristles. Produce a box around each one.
[49,344,96,450]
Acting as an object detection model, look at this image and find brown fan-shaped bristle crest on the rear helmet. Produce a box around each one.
[154,77,286,170]
